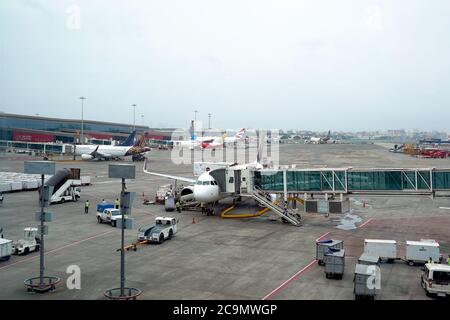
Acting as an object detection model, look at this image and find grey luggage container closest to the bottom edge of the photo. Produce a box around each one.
[353,264,380,300]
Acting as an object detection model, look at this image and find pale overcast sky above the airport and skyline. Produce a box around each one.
[0,0,450,131]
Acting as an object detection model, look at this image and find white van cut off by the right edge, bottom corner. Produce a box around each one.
[421,263,450,297]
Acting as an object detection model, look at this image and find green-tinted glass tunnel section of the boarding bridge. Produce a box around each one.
[252,168,450,195]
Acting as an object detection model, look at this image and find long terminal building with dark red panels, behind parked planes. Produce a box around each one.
[0,113,181,153]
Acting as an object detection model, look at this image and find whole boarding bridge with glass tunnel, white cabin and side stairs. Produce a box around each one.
[210,165,450,226]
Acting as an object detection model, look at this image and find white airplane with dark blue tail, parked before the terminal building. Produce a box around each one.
[75,131,150,160]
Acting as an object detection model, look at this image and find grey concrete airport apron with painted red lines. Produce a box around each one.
[0,144,450,300]
